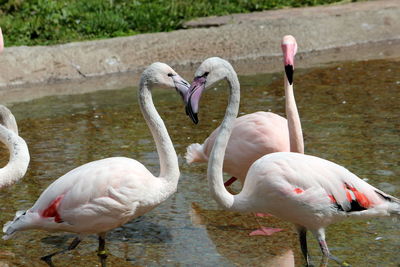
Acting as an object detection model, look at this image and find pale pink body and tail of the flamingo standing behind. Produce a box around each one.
[186,111,290,183]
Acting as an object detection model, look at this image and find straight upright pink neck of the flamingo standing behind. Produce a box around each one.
[284,75,304,154]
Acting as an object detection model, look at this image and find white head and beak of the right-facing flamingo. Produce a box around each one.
[141,62,190,100]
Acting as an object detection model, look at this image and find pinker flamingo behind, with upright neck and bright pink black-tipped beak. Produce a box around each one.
[185,35,304,186]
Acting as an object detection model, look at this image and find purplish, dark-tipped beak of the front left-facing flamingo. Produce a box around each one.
[185,76,207,124]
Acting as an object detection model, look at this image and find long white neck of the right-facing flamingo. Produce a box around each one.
[139,81,179,183]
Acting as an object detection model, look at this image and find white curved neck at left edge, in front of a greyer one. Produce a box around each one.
[0,125,30,188]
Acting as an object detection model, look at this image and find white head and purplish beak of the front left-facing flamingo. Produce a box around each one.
[185,57,235,124]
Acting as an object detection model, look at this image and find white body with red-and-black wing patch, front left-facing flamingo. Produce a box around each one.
[241,152,400,230]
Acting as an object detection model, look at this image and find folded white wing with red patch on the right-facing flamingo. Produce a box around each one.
[30,157,153,229]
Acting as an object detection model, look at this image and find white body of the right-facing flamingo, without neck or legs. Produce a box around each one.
[4,157,171,238]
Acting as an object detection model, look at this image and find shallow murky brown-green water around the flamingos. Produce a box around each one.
[0,58,400,266]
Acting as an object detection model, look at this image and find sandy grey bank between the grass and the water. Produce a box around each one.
[0,0,400,103]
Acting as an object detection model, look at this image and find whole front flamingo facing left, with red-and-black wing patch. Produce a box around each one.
[187,57,400,266]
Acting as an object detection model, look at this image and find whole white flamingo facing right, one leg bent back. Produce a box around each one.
[3,62,189,266]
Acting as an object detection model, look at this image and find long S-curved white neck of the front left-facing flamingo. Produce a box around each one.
[207,72,240,213]
